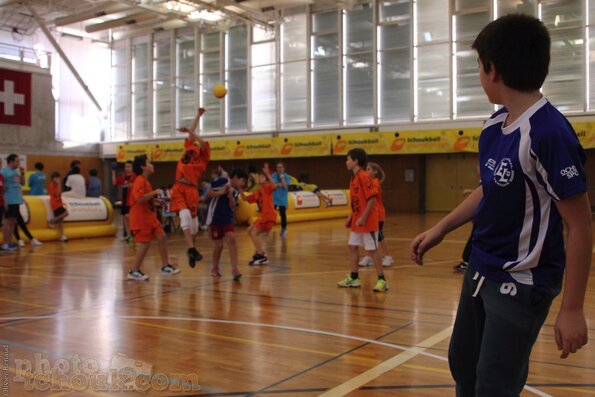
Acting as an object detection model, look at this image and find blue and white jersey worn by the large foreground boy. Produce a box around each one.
[470,98,587,285]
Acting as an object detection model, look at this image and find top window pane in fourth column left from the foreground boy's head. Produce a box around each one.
[344,4,374,54]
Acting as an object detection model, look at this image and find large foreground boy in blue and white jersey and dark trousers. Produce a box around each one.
[410,14,592,396]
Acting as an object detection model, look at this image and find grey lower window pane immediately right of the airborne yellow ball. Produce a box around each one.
[228,69,248,133]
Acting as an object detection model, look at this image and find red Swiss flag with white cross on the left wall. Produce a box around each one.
[0,68,31,126]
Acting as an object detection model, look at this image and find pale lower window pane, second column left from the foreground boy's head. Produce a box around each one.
[417,44,450,120]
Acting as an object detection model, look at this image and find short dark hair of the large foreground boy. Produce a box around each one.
[471,14,551,91]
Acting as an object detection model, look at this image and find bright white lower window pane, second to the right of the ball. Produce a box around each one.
[252,65,277,131]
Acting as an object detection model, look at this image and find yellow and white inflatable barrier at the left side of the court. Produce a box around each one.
[14,195,118,241]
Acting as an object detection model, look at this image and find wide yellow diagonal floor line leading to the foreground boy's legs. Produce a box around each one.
[319,327,452,397]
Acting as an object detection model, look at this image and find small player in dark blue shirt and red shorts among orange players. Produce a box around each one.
[206,169,248,281]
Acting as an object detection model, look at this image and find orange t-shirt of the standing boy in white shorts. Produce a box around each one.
[349,169,378,233]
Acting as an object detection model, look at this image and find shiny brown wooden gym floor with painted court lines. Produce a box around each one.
[0,214,595,397]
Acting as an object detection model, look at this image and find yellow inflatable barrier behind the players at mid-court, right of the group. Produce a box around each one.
[236,190,351,223]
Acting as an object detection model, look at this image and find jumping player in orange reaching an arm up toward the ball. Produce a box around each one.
[171,108,211,267]
